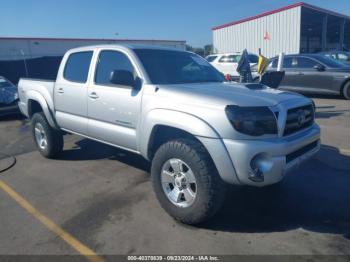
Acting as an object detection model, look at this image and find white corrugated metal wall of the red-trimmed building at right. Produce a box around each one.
[213,6,301,57]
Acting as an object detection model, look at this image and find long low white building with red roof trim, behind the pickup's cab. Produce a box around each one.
[0,37,186,61]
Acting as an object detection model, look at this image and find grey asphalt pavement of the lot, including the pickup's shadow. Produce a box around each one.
[0,94,350,255]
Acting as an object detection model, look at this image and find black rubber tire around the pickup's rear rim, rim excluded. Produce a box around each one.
[31,112,63,158]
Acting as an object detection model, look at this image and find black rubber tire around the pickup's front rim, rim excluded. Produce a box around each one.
[151,139,227,225]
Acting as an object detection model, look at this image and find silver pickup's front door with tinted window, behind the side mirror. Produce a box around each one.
[88,50,141,150]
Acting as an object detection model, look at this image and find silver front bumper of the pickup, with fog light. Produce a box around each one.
[223,124,320,187]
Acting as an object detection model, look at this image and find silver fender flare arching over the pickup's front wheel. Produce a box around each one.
[138,109,219,159]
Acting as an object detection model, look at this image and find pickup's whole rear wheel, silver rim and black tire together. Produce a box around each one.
[32,113,63,158]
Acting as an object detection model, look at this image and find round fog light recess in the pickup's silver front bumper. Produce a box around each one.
[249,153,273,182]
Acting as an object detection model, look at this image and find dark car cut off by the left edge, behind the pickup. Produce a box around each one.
[0,76,19,116]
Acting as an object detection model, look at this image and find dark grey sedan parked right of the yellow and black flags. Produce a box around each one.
[251,54,350,99]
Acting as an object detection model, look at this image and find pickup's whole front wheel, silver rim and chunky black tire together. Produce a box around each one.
[151,139,226,225]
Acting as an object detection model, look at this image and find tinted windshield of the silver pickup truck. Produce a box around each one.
[135,49,224,84]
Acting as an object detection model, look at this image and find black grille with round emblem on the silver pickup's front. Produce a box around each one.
[283,105,314,136]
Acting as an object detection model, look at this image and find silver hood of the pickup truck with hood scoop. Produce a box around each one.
[160,83,310,106]
